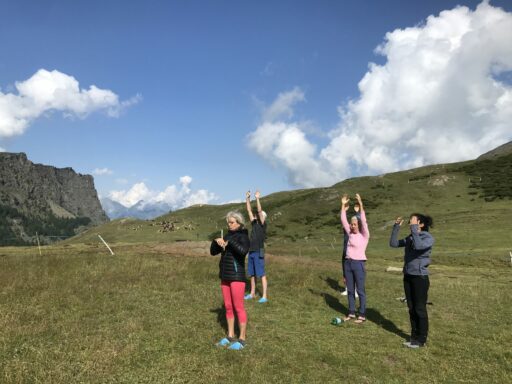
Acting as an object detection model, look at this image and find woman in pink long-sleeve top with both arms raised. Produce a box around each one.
[341,194,370,323]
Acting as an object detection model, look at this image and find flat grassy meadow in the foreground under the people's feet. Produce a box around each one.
[0,244,512,383]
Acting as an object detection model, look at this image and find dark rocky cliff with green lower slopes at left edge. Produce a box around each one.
[0,152,108,244]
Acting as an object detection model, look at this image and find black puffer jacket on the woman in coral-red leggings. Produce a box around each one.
[210,228,250,282]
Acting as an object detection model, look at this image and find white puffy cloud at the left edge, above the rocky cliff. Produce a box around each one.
[0,69,141,138]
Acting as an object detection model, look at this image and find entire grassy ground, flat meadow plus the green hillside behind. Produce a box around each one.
[0,153,512,383]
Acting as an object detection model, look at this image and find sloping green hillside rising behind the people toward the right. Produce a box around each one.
[66,154,512,262]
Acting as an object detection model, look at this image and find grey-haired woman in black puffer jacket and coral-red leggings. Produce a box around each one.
[210,212,250,350]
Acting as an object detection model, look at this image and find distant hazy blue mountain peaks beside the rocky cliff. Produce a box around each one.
[100,197,172,220]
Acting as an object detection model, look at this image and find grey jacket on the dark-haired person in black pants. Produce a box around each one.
[389,224,434,275]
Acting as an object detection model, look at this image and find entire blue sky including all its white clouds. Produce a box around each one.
[0,0,512,209]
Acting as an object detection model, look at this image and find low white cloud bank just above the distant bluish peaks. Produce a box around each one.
[109,176,218,209]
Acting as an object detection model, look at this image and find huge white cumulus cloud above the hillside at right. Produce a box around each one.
[249,1,512,186]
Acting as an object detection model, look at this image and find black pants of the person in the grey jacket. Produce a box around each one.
[404,275,430,343]
